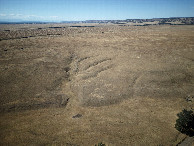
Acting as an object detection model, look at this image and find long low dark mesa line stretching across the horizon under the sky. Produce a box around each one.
[0,17,194,25]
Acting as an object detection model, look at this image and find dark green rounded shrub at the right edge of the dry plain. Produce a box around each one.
[175,109,194,136]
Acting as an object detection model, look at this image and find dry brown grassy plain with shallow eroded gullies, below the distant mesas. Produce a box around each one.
[0,24,194,146]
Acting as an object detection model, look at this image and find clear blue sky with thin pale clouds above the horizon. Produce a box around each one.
[0,0,194,21]
